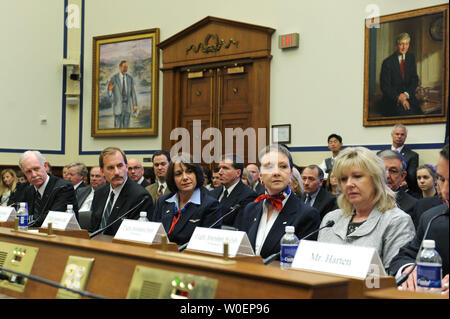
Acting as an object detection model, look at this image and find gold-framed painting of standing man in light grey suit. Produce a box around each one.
[91,28,159,137]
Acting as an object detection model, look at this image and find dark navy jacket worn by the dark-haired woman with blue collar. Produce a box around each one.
[151,188,222,245]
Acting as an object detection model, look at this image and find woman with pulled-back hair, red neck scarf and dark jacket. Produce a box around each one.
[240,144,320,258]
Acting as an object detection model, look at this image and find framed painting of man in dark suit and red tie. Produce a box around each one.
[363,4,449,126]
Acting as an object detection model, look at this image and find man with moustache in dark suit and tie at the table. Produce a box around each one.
[89,147,154,236]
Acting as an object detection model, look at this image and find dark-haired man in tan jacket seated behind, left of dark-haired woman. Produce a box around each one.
[145,150,170,204]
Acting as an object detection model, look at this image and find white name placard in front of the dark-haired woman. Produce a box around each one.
[114,219,166,244]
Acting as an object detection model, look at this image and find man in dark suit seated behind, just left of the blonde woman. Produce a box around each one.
[302,165,337,220]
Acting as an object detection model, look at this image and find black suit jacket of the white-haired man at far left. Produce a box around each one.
[24,174,78,227]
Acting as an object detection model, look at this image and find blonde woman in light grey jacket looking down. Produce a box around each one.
[318,147,415,269]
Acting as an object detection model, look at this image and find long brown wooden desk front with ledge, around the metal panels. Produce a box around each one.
[0,228,349,299]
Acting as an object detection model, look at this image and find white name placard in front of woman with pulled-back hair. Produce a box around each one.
[187,227,255,257]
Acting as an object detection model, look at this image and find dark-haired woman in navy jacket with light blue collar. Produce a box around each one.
[151,155,222,245]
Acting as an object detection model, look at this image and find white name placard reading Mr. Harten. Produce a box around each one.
[292,240,387,279]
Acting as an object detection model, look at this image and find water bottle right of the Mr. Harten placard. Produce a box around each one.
[416,239,442,293]
